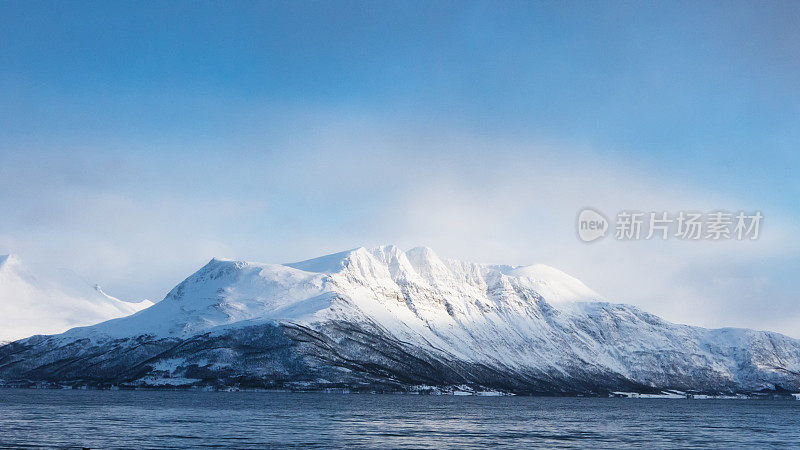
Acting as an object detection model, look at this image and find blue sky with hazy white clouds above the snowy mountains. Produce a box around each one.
[0,2,800,336]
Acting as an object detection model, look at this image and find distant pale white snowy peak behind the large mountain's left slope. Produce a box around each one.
[0,255,153,342]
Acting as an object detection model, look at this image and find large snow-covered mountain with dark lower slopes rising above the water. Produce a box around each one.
[0,246,800,393]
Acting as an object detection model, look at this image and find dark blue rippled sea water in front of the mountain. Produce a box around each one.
[0,389,800,449]
